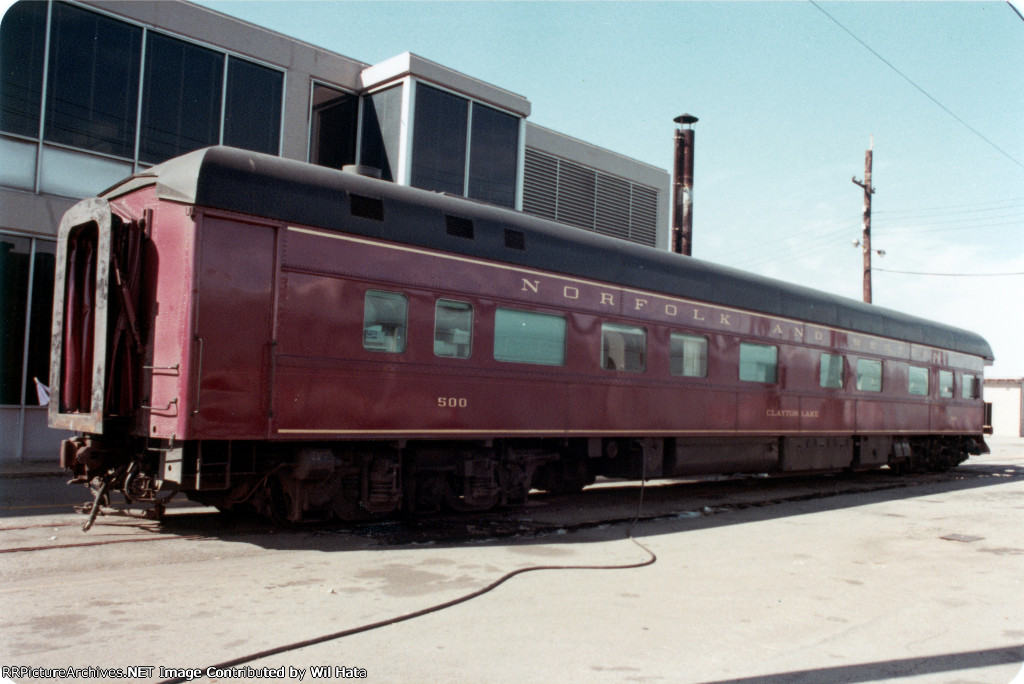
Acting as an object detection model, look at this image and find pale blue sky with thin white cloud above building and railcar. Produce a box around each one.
[169,0,1024,377]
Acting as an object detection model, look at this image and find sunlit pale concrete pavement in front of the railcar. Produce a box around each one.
[0,440,1024,684]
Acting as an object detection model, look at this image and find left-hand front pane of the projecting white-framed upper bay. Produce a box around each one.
[411,83,469,195]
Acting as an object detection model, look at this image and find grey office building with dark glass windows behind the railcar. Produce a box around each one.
[0,0,670,460]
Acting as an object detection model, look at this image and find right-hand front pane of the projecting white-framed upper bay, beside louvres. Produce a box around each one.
[469,103,519,207]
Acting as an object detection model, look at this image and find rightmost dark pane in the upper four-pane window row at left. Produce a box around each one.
[224,57,285,155]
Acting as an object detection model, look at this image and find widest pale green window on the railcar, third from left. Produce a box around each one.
[495,308,566,366]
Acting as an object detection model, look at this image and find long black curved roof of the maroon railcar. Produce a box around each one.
[103,146,993,359]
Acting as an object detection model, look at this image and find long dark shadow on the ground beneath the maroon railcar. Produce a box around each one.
[142,465,1024,552]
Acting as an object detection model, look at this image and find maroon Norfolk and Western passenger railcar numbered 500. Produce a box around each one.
[49,147,992,521]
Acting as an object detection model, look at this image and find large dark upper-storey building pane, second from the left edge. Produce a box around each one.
[45,2,142,158]
